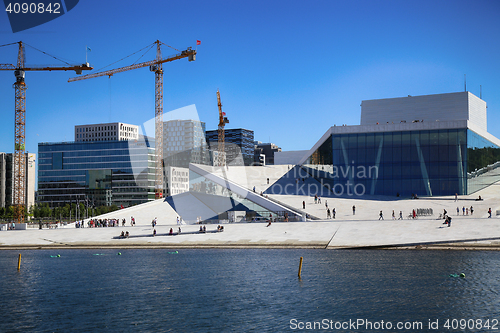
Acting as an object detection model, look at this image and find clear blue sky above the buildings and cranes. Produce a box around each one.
[0,0,500,158]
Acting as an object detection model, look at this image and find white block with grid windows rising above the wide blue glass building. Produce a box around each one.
[75,123,139,142]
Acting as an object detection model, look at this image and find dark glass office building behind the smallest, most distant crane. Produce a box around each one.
[206,128,254,165]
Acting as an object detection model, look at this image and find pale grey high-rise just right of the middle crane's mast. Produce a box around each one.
[163,120,210,168]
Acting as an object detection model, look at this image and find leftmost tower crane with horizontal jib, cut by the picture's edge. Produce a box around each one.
[0,41,93,223]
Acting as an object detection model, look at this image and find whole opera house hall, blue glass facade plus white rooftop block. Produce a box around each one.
[294,92,500,196]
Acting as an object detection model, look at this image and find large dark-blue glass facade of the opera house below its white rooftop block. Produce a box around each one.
[302,129,500,196]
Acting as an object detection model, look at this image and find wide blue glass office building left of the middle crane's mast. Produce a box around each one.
[38,140,155,207]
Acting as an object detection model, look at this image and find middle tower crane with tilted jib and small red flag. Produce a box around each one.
[68,40,196,198]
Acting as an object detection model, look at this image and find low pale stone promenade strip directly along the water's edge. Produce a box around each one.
[0,218,500,249]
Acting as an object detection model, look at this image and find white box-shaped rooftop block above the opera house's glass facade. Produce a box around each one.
[361,91,487,131]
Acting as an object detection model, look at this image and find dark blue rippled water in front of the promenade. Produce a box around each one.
[0,249,500,332]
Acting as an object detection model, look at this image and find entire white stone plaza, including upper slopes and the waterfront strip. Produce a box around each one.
[0,166,500,249]
